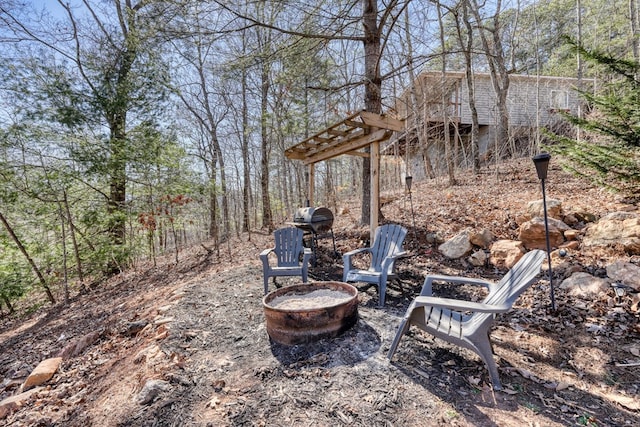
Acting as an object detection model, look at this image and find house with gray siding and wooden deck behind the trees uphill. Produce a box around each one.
[384,72,595,179]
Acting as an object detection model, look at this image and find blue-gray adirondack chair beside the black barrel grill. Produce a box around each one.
[260,227,311,295]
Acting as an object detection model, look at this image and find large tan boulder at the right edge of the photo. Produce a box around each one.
[582,212,640,255]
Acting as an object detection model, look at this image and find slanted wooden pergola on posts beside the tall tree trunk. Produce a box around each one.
[284,111,404,240]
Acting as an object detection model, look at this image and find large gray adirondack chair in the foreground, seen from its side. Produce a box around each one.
[387,250,546,390]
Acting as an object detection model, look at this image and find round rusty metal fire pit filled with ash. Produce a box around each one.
[262,282,358,345]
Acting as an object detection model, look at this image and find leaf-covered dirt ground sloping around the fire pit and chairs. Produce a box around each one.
[0,159,640,427]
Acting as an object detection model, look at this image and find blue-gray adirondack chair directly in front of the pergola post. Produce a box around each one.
[342,224,407,307]
